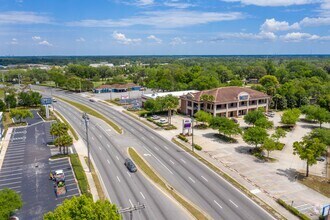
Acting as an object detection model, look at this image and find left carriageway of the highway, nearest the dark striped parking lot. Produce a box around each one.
[54,101,190,219]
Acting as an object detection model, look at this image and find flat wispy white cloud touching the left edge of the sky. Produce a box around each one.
[0,11,50,24]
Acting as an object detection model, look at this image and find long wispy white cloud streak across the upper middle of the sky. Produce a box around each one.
[67,10,244,28]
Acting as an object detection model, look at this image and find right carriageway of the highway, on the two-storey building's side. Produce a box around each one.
[42,86,273,220]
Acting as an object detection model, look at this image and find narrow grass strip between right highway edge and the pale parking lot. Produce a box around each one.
[172,138,285,219]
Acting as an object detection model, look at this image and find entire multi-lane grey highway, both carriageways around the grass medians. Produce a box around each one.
[41,87,273,220]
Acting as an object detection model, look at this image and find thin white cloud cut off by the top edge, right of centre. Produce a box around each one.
[223,0,322,7]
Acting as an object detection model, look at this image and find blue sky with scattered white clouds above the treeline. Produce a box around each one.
[0,0,330,56]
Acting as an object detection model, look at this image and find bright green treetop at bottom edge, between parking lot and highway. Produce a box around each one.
[44,195,121,220]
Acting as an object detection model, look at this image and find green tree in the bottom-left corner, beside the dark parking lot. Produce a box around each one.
[0,189,23,219]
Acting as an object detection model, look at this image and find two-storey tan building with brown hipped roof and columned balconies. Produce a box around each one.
[180,86,270,117]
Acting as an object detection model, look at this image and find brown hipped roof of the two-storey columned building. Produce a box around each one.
[182,86,269,103]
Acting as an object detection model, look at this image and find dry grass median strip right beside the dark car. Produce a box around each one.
[128,148,208,220]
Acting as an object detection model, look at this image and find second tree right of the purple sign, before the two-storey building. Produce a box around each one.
[210,117,241,137]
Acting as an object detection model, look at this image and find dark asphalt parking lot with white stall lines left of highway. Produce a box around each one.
[0,112,79,220]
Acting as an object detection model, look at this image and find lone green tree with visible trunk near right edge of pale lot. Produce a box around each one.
[293,137,326,177]
